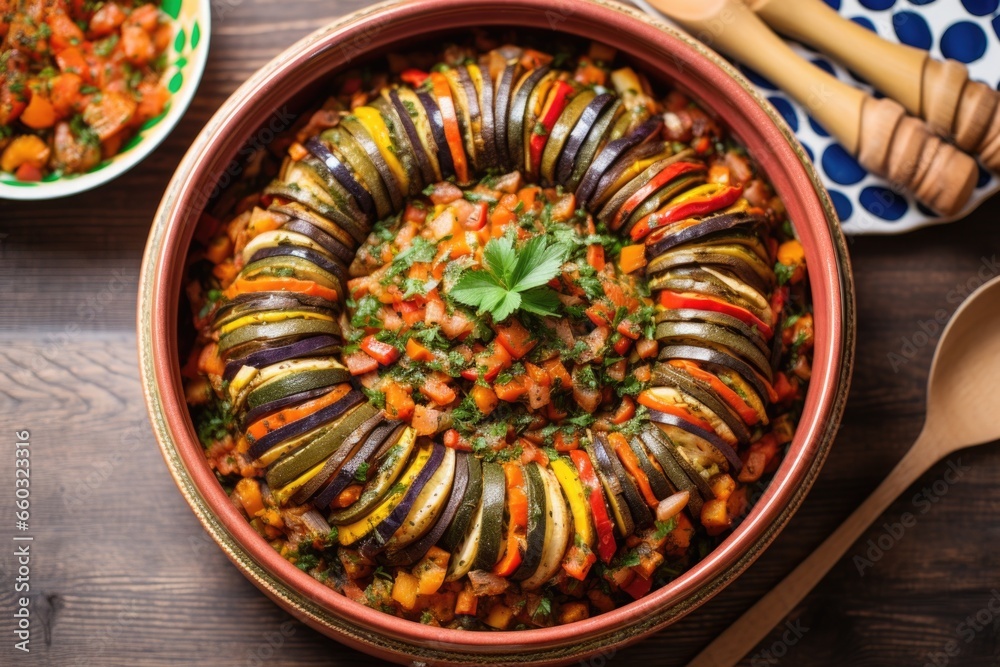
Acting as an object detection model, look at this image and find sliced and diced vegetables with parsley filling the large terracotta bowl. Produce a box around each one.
[184,39,812,629]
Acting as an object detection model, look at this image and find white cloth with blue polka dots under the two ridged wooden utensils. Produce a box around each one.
[633,0,1000,234]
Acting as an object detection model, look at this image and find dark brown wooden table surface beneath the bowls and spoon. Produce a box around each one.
[0,0,1000,667]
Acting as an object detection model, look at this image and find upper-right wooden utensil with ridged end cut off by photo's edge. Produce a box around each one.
[744,0,1000,171]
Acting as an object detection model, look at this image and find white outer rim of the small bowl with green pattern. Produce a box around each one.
[0,0,212,201]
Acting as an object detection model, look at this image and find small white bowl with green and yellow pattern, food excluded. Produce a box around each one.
[0,0,212,200]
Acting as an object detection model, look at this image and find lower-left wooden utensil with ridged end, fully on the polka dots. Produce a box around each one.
[649,0,980,215]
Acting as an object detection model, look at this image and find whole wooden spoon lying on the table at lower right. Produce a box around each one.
[689,278,1000,667]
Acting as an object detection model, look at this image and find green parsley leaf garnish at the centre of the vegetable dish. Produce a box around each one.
[451,236,564,322]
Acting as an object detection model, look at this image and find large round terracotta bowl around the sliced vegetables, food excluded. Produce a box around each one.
[138,0,855,665]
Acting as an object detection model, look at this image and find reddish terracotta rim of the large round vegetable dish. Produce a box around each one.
[137,0,855,664]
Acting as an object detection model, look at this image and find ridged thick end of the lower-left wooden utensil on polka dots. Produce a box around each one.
[858,97,979,215]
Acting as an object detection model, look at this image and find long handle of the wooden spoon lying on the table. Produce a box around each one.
[688,432,937,667]
